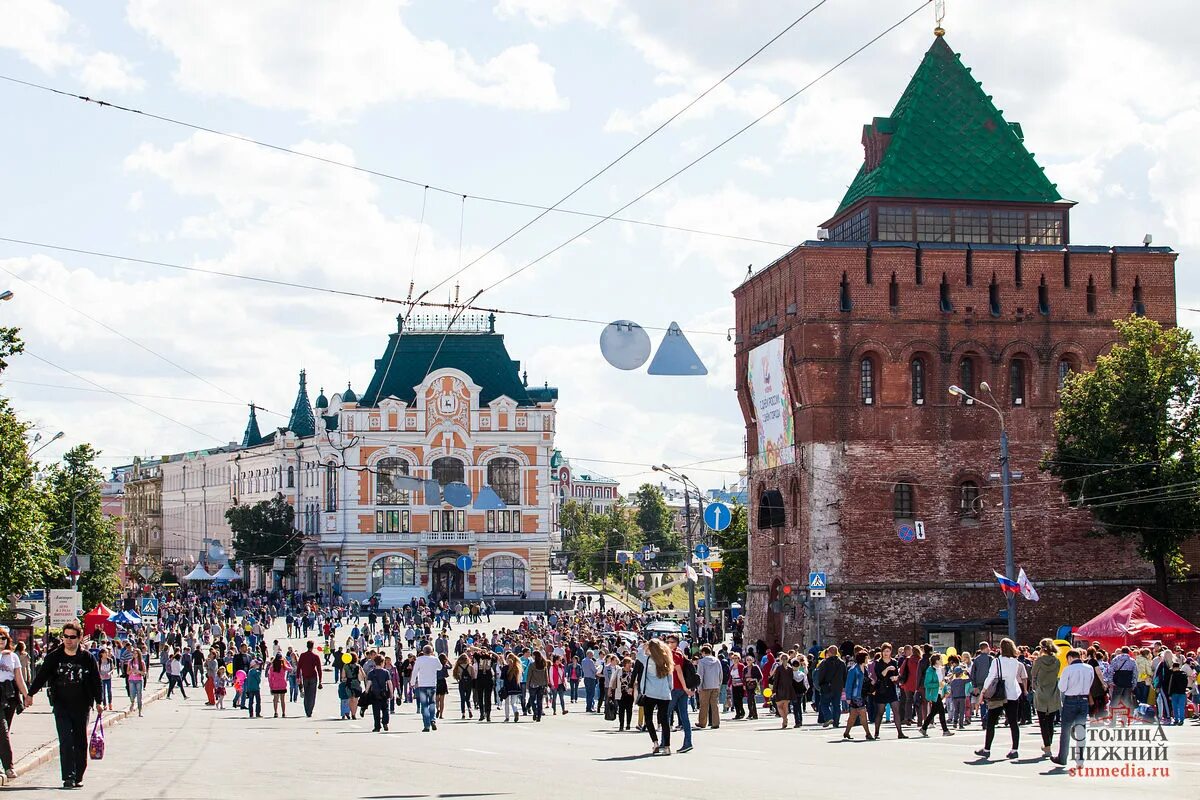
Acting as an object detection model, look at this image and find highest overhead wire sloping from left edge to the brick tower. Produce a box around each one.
[0,74,792,247]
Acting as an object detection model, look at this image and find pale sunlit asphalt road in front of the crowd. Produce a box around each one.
[9,616,1200,800]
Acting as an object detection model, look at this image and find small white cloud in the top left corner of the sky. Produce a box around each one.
[0,0,145,92]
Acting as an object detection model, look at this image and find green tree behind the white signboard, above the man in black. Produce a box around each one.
[46,444,121,609]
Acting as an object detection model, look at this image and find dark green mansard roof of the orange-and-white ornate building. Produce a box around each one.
[359,331,558,408]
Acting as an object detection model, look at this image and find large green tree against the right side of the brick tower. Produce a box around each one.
[1043,317,1200,604]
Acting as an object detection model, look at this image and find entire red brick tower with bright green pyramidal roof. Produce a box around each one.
[734,36,1176,649]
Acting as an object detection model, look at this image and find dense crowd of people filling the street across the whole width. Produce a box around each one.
[0,593,1200,787]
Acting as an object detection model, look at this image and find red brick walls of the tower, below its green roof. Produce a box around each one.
[734,242,1200,644]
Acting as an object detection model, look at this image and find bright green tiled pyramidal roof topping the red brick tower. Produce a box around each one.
[838,36,1062,213]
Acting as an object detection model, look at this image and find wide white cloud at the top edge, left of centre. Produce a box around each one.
[128,0,566,121]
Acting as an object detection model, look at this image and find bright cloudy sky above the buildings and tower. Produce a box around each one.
[0,0,1200,489]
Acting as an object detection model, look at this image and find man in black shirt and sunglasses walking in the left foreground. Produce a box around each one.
[29,621,103,789]
